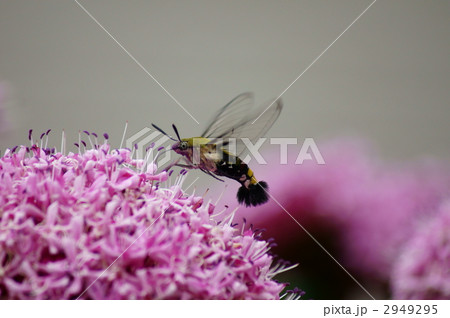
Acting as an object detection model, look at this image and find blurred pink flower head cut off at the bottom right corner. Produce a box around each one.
[391,202,450,299]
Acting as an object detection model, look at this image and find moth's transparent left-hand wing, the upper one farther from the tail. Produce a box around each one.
[201,93,254,138]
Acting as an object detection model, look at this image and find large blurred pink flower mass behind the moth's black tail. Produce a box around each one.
[214,140,450,281]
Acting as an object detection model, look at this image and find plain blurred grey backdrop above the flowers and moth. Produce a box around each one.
[0,0,450,160]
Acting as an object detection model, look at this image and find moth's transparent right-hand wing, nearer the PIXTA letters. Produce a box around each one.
[211,99,283,156]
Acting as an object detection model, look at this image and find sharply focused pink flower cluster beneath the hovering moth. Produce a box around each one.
[0,137,294,299]
